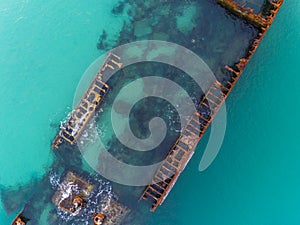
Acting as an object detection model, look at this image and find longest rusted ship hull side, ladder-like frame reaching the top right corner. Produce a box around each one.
[141,0,283,212]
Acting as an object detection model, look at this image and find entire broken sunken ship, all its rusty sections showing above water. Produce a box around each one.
[11,0,283,225]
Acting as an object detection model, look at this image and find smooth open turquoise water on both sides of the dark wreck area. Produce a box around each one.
[0,0,300,225]
